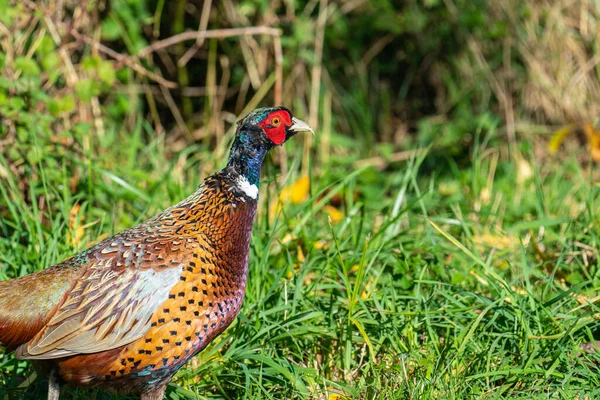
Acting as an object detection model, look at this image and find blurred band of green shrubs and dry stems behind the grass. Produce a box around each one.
[0,0,600,209]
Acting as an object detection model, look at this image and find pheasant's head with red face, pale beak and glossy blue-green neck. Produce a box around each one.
[227,106,314,185]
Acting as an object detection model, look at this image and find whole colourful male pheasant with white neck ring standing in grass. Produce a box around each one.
[0,107,313,400]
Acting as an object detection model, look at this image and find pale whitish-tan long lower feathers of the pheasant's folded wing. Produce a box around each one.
[16,260,182,359]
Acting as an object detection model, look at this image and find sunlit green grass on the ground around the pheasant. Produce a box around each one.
[0,124,600,399]
